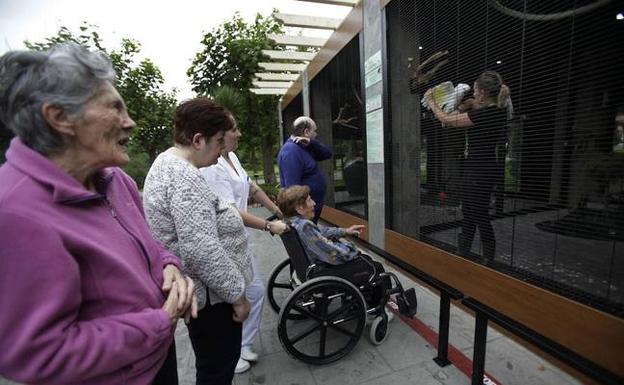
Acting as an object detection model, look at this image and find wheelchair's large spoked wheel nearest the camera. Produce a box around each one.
[277,276,366,365]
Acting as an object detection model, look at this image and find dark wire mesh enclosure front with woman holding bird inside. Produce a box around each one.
[385,0,624,316]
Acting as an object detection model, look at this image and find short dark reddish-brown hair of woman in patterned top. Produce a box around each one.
[173,97,235,146]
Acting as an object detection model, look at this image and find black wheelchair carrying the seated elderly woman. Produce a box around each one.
[267,222,417,365]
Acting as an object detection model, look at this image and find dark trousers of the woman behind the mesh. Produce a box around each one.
[458,179,496,259]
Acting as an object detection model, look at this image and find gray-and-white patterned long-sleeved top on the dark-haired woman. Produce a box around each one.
[143,151,253,308]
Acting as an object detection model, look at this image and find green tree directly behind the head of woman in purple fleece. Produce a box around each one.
[25,23,176,186]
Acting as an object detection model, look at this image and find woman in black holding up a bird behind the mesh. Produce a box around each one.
[425,71,509,263]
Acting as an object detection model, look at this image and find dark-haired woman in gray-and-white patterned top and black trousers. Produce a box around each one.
[143,97,253,385]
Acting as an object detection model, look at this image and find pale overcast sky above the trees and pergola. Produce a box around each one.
[0,0,348,99]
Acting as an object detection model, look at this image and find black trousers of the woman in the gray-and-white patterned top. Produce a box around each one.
[187,302,242,385]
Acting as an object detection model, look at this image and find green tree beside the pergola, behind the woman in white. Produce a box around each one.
[187,13,282,184]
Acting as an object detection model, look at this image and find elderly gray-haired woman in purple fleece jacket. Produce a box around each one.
[0,44,196,385]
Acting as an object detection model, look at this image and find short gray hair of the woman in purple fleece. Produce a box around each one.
[0,43,115,155]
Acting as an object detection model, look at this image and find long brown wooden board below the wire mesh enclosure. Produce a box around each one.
[385,230,624,377]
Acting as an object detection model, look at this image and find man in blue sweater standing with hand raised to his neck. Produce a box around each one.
[277,116,332,223]
